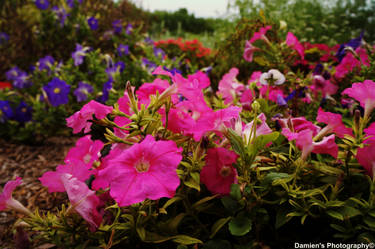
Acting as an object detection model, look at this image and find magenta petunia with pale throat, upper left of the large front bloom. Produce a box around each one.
[64,135,104,167]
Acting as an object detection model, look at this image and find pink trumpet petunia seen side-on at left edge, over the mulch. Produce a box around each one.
[0,177,31,215]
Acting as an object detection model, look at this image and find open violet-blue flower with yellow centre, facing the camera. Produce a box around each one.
[43,77,70,106]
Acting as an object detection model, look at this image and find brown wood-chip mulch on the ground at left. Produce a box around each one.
[0,137,76,248]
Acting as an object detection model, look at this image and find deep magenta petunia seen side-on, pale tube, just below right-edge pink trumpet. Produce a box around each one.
[316,108,353,138]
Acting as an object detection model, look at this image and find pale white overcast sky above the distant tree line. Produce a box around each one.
[131,0,232,17]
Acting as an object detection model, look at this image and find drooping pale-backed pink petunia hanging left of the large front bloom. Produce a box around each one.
[60,173,103,231]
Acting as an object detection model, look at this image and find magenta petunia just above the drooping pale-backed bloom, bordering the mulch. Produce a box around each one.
[39,159,94,193]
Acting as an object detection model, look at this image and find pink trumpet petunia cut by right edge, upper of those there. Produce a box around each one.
[341,80,375,117]
